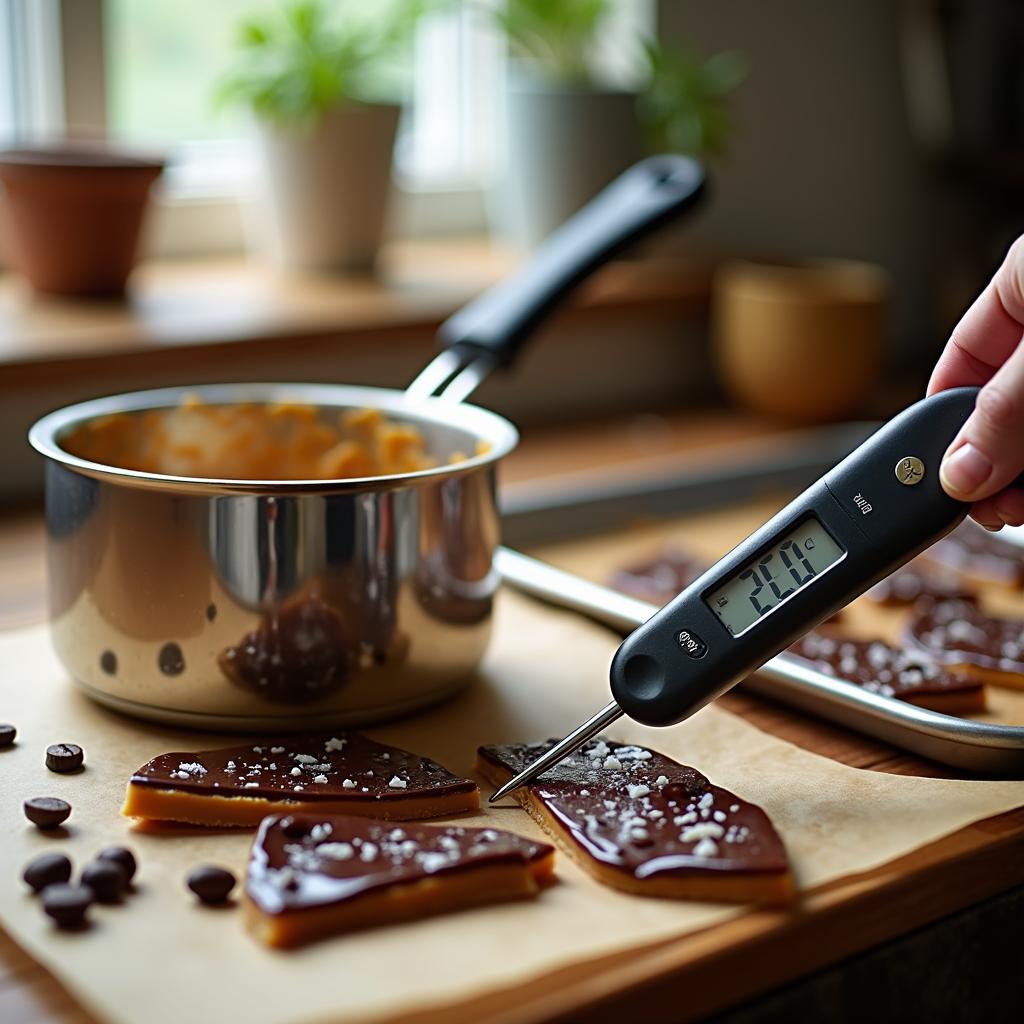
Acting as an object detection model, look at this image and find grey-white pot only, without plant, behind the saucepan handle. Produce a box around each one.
[492,72,643,248]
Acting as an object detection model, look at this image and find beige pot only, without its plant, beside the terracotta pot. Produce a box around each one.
[253,103,399,270]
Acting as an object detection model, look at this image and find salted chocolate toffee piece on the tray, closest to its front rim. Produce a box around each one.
[786,632,985,715]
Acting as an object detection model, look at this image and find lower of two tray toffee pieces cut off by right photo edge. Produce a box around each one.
[904,601,1024,689]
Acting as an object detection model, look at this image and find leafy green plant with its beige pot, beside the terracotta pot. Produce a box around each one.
[220,0,431,270]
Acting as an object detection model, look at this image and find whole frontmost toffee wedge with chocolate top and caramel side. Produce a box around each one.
[244,814,555,947]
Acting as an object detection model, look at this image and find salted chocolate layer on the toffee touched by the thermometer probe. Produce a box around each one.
[478,739,787,882]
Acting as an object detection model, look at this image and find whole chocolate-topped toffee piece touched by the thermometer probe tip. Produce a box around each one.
[477,739,794,903]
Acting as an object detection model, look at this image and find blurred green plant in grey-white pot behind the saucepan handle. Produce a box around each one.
[488,0,744,246]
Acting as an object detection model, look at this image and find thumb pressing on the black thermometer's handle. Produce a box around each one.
[939,342,1024,502]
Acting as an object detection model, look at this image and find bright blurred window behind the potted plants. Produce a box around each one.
[0,0,652,254]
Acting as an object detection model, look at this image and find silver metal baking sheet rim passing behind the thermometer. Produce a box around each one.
[497,424,1024,777]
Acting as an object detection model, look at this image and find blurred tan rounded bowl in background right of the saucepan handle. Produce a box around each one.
[712,260,889,423]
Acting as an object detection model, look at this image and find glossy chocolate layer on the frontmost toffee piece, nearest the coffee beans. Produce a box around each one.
[246,814,552,914]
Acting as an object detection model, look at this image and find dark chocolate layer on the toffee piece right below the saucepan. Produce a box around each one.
[131,732,476,803]
